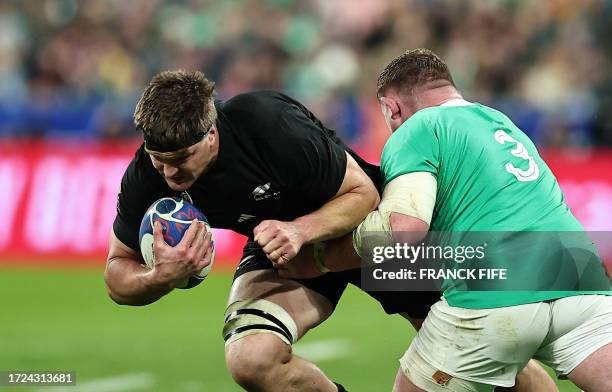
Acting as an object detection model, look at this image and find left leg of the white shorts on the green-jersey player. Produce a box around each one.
[400,300,550,389]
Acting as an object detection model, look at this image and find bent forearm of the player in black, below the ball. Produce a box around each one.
[104,258,172,306]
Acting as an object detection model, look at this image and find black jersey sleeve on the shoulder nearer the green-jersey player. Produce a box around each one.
[224,91,347,208]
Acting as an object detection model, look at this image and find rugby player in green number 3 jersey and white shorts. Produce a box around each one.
[279,49,612,392]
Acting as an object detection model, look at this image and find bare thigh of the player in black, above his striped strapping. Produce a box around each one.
[226,269,335,340]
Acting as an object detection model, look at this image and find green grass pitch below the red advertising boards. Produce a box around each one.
[0,269,578,392]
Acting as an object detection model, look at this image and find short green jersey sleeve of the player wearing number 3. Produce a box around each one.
[381,116,440,185]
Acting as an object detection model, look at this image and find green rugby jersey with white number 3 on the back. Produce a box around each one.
[381,100,612,309]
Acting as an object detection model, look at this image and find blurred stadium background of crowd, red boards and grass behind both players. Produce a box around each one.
[0,0,612,392]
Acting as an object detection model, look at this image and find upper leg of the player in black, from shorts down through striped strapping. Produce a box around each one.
[223,241,347,346]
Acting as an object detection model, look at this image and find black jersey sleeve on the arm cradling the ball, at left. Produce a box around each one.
[113,148,169,252]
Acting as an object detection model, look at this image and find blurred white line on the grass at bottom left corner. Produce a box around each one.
[36,373,155,392]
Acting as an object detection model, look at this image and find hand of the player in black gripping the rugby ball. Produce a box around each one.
[152,220,212,288]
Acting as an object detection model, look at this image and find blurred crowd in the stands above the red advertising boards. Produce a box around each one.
[0,0,612,155]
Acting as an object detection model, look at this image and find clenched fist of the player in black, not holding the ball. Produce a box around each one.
[253,220,305,266]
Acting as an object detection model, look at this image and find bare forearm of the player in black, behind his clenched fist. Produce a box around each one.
[293,184,379,244]
